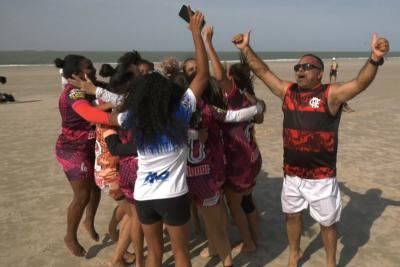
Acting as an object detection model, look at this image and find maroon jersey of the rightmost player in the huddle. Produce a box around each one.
[223,86,262,192]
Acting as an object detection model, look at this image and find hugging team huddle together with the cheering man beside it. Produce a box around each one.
[55,7,389,267]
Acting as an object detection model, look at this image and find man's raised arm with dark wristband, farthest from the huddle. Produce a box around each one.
[328,33,389,114]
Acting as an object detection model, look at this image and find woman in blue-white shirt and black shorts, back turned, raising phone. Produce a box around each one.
[118,9,209,267]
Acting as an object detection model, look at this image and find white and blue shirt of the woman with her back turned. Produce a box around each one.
[118,89,196,201]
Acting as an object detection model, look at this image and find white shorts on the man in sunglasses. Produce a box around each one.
[281,176,342,226]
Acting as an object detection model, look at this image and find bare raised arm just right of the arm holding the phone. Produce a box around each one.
[203,25,233,92]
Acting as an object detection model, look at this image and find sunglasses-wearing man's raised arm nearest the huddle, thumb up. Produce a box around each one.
[232,31,290,99]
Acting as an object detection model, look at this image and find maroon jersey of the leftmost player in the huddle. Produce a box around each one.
[57,84,95,151]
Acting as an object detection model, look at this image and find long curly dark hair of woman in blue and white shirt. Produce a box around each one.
[122,72,187,151]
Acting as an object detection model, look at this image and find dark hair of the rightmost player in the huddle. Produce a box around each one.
[229,53,254,95]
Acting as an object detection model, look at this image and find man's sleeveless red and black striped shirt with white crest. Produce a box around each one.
[282,84,342,179]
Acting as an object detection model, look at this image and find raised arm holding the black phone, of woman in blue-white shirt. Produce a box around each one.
[189,9,210,101]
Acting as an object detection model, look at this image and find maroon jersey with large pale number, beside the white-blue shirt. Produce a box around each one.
[187,102,226,190]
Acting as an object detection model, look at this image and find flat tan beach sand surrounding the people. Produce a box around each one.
[0,59,400,267]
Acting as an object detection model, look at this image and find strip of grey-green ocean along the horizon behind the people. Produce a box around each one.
[0,50,400,66]
